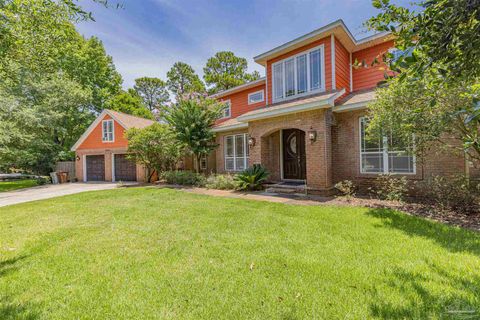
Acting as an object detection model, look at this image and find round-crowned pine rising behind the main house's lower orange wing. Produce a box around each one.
[203,51,260,93]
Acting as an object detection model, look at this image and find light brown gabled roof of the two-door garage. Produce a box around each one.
[70,109,155,151]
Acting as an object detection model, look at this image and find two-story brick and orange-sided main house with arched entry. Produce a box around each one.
[203,20,473,193]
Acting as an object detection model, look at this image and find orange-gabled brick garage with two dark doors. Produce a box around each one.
[72,110,154,182]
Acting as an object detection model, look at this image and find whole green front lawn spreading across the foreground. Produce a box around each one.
[0,188,480,319]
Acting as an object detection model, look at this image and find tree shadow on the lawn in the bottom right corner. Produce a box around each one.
[370,262,480,319]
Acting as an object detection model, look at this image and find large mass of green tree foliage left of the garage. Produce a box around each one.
[0,0,121,173]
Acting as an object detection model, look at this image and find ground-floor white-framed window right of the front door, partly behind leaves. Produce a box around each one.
[360,118,415,174]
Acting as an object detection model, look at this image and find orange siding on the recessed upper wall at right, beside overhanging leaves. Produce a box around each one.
[352,41,394,91]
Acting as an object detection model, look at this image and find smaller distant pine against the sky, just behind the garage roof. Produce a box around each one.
[133,77,170,114]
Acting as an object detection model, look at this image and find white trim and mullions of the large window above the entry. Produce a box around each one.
[270,44,325,102]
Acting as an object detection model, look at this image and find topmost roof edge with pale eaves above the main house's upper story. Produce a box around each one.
[253,19,392,65]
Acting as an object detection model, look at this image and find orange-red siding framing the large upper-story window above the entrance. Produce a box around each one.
[267,36,332,104]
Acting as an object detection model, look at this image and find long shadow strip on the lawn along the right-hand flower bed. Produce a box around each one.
[367,209,480,256]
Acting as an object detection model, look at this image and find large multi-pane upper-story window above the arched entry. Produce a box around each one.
[272,45,325,101]
